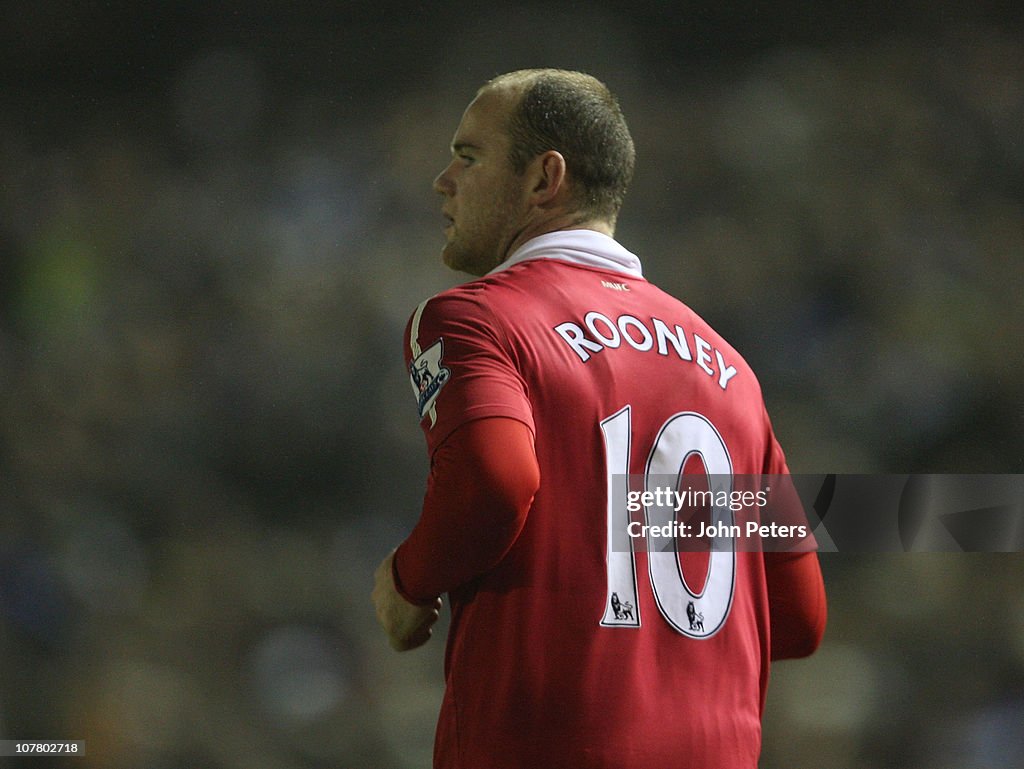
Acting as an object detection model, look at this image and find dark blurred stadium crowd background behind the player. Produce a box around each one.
[0,0,1024,769]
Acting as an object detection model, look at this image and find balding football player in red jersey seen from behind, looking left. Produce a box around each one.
[373,70,825,769]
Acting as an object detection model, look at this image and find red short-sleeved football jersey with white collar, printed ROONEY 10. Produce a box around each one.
[401,230,806,769]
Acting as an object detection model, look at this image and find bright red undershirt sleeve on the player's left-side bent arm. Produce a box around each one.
[393,417,541,603]
